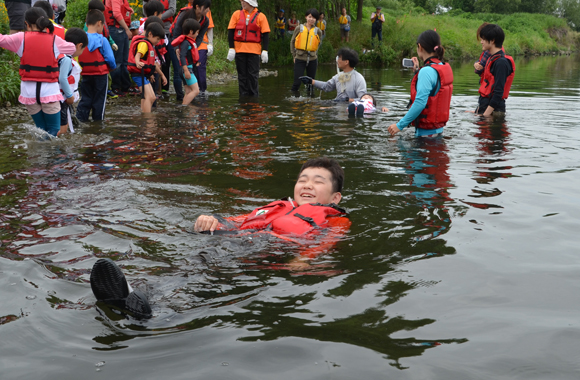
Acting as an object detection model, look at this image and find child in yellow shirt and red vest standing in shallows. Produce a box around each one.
[127,22,167,113]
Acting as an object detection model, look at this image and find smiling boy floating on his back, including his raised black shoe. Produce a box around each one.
[91,157,350,319]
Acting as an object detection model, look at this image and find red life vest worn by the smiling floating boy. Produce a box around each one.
[240,200,346,235]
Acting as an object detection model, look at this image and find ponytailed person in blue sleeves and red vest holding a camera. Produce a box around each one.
[388,30,453,137]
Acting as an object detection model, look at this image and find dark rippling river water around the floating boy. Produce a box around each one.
[0,56,580,380]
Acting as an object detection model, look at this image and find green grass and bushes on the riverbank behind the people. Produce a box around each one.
[0,0,580,104]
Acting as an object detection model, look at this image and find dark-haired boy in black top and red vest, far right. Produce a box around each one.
[475,24,516,116]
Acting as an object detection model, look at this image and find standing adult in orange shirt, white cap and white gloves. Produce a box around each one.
[227,0,270,96]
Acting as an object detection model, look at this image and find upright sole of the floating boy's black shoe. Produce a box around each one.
[91,259,129,301]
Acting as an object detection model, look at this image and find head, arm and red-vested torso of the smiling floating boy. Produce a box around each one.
[194,157,350,253]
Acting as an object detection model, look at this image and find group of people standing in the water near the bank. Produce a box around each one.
[0,0,515,143]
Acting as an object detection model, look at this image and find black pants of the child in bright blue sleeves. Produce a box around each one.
[77,74,109,121]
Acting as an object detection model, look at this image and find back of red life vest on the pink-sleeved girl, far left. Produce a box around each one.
[19,32,58,83]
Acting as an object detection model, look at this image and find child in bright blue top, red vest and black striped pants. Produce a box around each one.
[77,9,116,122]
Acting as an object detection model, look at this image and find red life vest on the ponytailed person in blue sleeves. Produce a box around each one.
[409,57,453,129]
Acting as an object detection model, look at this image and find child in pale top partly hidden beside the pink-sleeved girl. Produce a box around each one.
[58,28,89,136]
